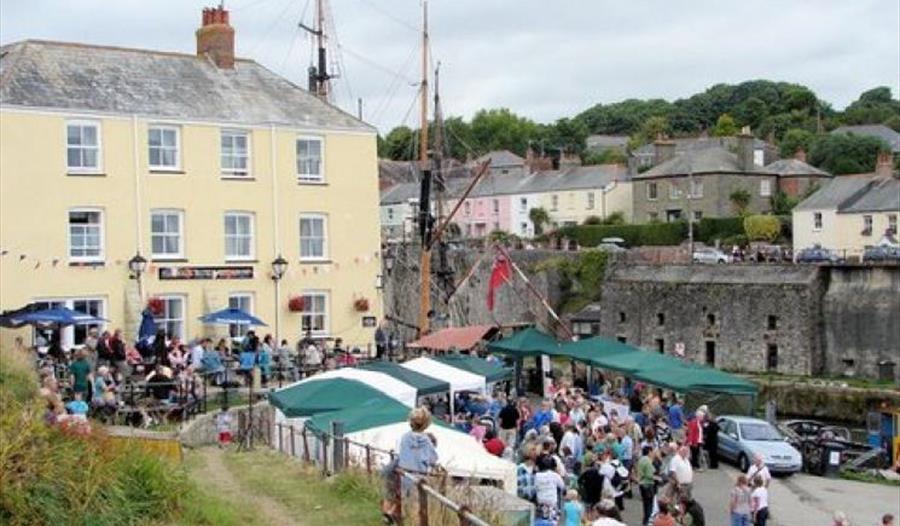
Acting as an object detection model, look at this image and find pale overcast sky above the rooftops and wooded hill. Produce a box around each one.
[0,0,900,131]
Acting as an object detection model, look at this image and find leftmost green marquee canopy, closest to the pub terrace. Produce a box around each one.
[269,378,394,418]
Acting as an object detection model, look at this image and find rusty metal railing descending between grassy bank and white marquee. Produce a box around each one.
[269,422,490,526]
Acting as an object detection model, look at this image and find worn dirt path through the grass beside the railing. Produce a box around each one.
[191,447,302,526]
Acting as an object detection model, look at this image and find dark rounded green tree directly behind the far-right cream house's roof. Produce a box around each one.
[808,133,890,175]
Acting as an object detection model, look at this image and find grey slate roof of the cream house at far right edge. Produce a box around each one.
[794,174,900,213]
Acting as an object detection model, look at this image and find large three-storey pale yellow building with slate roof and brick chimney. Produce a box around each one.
[0,8,382,348]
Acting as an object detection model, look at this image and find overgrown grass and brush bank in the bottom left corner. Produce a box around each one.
[0,349,250,526]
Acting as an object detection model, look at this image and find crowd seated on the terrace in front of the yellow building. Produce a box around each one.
[21,328,372,429]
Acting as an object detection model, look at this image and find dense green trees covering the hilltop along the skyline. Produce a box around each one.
[378,80,900,173]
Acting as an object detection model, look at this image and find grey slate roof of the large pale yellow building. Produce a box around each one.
[0,40,375,133]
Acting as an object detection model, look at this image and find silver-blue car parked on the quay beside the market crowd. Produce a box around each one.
[716,416,803,475]
